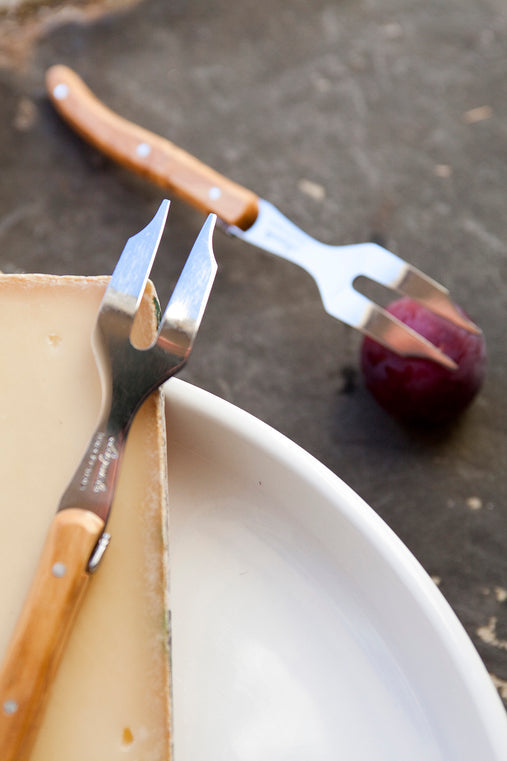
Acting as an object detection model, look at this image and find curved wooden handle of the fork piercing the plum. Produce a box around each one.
[46,65,259,230]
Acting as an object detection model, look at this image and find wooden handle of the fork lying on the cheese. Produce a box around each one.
[0,508,104,761]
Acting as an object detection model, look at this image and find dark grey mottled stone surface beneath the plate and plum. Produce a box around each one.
[0,0,507,712]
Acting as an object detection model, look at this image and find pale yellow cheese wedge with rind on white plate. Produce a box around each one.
[0,275,171,761]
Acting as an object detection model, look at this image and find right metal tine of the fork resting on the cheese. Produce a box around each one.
[160,214,217,353]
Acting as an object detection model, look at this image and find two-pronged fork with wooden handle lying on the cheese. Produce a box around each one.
[0,201,216,761]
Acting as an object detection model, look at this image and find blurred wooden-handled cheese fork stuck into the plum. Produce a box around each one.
[46,65,481,369]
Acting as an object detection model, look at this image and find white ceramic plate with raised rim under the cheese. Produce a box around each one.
[166,380,507,761]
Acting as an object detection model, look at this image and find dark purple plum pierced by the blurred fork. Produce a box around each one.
[361,297,486,425]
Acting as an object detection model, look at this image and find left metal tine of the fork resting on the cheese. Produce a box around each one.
[103,200,169,318]
